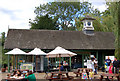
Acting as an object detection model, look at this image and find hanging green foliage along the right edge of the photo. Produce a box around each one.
[107,2,120,59]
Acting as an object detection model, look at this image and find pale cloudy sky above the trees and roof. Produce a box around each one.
[0,0,107,36]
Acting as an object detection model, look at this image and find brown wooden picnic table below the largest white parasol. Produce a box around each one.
[46,71,74,81]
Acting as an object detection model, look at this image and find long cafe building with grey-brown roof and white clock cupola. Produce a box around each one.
[4,16,115,71]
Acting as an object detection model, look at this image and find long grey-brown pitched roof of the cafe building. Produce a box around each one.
[4,29,115,50]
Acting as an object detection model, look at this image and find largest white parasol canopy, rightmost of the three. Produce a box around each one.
[46,46,77,57]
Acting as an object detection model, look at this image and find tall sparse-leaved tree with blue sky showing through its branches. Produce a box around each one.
[35,2,93,30]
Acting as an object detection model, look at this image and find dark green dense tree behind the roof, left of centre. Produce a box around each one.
[29,15,57,30]
